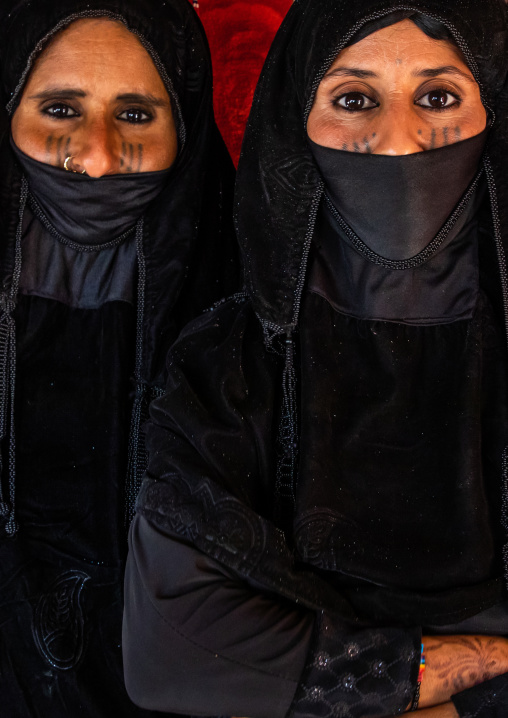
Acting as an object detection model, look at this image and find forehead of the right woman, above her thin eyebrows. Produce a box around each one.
[332,19,470,74]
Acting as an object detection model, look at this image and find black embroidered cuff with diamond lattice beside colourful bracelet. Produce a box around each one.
[288,613,421,718]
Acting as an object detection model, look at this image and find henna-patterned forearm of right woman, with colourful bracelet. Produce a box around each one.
[418,636,508,718]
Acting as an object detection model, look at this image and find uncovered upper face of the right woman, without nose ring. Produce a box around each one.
[307,20,487,155]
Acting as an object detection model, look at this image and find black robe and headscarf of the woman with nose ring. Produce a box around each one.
[0,0,237,718]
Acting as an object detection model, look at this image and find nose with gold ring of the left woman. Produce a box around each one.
[72,118,120,177]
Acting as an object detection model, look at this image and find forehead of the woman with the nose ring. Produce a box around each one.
[27,18,165,92]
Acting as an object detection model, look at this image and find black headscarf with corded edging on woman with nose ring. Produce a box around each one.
[0,0,237,533]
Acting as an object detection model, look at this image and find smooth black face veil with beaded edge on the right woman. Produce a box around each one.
[309,130,488,260]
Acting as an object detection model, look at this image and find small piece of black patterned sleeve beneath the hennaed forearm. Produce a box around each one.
[452,673,508,718]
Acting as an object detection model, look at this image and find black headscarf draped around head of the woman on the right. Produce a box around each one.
[236,0,508,334]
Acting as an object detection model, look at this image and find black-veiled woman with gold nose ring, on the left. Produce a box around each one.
[0,0,236,718]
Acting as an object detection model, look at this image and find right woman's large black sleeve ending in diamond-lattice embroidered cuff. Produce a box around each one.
[123,515,420,718]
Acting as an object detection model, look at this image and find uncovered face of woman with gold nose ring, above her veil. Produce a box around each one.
[12,19,178,177]
